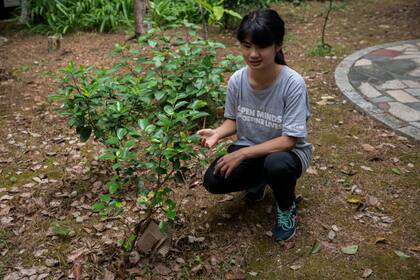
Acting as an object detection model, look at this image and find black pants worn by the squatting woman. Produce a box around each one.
[204,145,302,210]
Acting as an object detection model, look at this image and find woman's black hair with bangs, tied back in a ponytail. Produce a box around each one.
[236,9,286,65]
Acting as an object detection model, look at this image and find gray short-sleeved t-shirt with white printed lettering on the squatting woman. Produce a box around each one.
[224,66,312,173]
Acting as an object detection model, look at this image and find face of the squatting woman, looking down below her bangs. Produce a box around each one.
[241,40,281,70]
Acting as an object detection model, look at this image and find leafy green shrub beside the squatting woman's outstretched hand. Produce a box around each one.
[51,26,240,232]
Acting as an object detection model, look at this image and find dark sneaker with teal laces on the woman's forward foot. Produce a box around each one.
[272,202,297,241]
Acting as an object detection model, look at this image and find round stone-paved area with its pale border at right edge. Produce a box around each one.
[335,39,420,142]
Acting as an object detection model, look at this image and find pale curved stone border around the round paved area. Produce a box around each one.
[335,40,420,143]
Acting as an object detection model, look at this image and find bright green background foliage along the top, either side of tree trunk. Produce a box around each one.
[28,0,286,34]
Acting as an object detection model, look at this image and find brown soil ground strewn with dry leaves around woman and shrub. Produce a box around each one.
[0,0,420,279]
